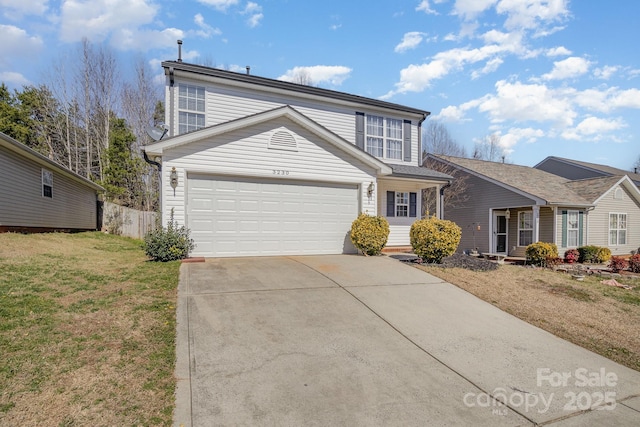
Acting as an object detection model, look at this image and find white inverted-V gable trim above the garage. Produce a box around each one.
[144,105,392,175]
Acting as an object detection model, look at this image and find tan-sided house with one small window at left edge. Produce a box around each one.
[0,133,103,232]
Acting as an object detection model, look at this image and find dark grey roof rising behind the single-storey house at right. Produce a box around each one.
[534,156,640,187]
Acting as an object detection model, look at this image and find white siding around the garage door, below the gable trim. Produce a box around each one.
[162,118,376,231]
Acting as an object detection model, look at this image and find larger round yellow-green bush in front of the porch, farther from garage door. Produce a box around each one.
[409,217,462,263]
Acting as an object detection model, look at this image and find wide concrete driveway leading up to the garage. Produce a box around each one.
[174,255,640,427]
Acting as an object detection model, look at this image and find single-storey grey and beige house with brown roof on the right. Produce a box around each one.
[427,154,640,257]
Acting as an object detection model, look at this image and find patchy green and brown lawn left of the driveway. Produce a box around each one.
[0,233,180,426]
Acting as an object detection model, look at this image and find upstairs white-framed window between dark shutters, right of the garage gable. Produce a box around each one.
[365,115,403,160]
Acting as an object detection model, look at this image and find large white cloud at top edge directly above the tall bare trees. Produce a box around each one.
[60,0,158,43]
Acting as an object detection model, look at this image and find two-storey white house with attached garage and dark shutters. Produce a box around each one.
[145,61,451,257]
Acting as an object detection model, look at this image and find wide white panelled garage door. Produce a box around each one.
[187,175,358,257]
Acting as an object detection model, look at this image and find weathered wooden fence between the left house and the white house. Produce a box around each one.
[102,202,157,239]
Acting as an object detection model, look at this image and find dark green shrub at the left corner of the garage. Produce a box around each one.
[144,209,195,262]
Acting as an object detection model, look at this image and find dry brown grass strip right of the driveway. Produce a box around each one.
[418,265,640,371]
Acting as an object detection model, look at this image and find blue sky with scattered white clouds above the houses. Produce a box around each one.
[0,0,640,169]
